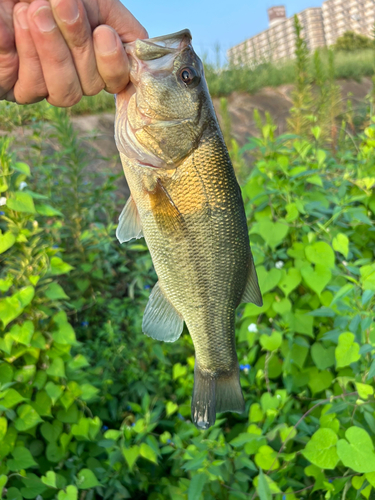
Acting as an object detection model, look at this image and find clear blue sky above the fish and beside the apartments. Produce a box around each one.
[121,0,323,63]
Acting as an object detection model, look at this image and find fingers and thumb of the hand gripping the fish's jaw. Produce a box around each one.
[8,0,147,107]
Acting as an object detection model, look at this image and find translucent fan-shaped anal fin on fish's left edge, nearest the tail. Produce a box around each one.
[142,283,184,342]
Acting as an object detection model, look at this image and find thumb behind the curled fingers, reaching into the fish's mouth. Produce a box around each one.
[87,0,148,42]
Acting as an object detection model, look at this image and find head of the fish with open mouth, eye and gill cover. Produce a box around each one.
[115,30,214,170]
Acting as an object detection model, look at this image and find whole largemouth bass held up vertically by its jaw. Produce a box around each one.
[115,30,262,430]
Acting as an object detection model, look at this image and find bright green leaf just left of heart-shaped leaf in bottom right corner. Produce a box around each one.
[302,429,341,469]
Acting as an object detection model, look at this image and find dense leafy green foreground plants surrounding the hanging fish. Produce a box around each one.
[0,18,375,500]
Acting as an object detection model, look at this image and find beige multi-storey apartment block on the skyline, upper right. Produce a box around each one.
[227,0,375,67]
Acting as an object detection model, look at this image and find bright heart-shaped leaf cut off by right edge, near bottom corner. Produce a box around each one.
[337,427,375,473]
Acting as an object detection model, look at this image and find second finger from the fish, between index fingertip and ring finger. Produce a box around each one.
[50,0,105,95]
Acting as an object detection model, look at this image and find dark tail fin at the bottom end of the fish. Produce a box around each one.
[191,363,245,430]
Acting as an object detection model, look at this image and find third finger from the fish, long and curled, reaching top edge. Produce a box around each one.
[27,0,82,107]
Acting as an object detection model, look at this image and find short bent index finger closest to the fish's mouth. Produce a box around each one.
[93,25,129,94]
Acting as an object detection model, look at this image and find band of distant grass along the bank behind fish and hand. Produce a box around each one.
[0,49,375,130]
